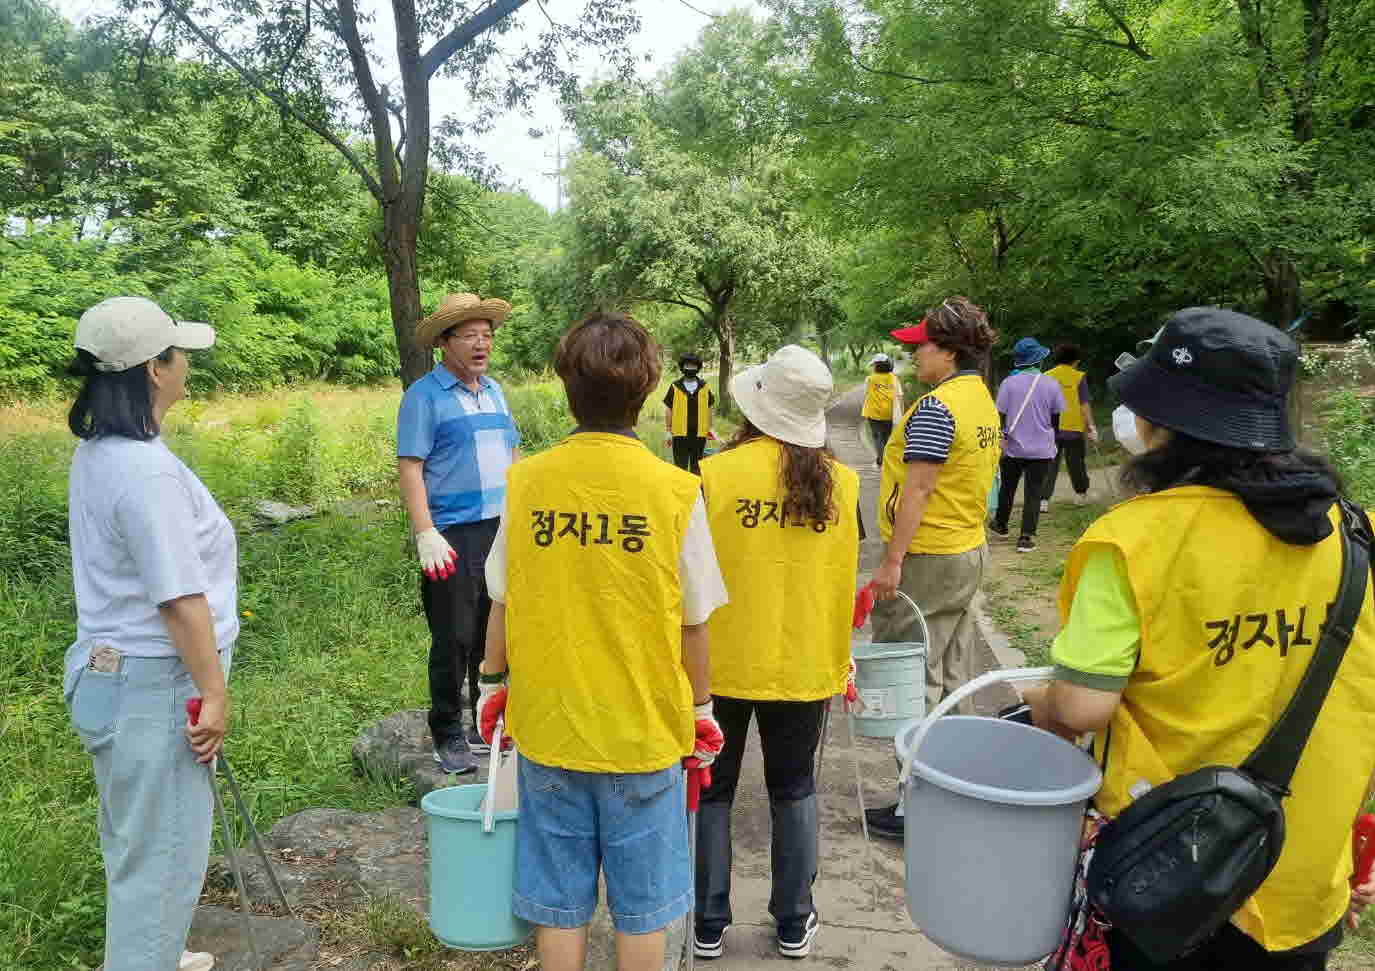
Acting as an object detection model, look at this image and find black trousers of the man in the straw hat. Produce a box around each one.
[421,519,501,747]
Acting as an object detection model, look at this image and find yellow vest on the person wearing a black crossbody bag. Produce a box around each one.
[1060,486,1375,950]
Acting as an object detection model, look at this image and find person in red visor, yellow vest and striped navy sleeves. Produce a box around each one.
[868,297,1002,839]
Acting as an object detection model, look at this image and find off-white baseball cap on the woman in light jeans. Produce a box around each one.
[76,297,215,371]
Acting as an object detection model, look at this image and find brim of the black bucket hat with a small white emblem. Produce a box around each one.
[1108,358,1294,451]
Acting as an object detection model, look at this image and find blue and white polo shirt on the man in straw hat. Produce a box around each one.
[396,364,520,530]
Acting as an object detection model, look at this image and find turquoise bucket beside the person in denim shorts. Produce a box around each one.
[421,785,532,950]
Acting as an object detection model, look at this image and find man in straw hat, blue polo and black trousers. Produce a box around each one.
[396,293,520,773]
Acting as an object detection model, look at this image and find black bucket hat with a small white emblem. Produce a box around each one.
[1108,307,1298,451]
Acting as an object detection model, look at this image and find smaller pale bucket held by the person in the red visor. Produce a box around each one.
[851,590,931,739]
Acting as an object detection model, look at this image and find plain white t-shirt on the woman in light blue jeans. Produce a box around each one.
[67,436,239,657]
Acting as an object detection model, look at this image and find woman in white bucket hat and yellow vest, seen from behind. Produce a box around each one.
[693,345,862,959]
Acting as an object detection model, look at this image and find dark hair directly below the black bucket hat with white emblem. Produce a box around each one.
[1122,429,1342,503]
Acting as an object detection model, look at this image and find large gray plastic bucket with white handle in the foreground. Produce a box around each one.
[898,668,1103,965]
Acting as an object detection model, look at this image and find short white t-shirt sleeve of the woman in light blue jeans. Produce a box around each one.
[114,473,210,605]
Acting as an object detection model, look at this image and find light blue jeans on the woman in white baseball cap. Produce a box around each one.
[63,642,232,971]
